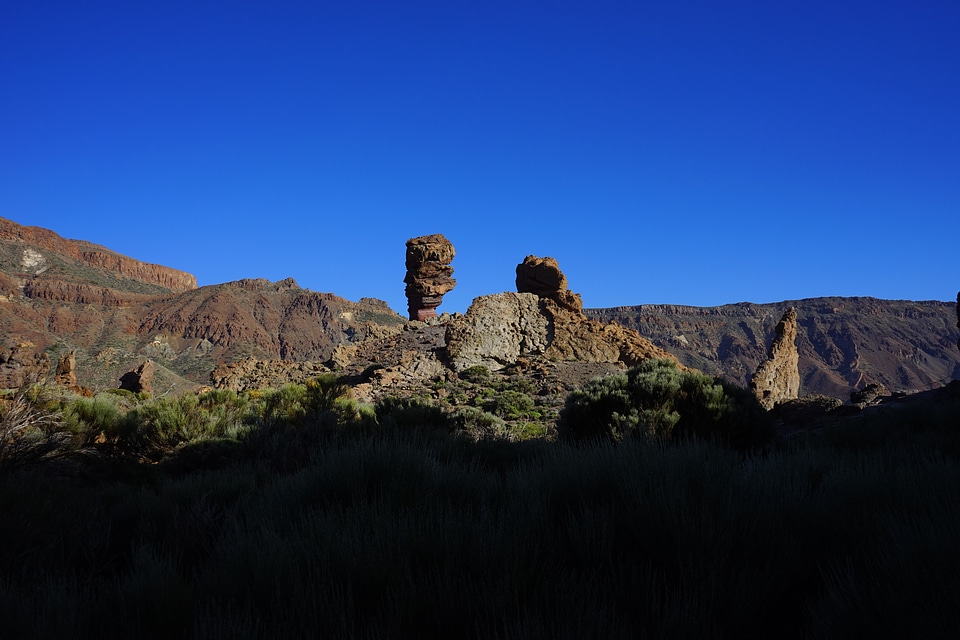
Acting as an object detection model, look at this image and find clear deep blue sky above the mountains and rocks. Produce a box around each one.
[0,0,960,312]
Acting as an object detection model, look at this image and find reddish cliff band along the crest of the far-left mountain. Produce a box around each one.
[0,218,197,292]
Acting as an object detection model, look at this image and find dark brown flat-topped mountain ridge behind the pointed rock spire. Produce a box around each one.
[585,297,960,399]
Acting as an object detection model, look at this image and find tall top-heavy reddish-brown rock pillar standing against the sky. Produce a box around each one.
[403,233,457,320]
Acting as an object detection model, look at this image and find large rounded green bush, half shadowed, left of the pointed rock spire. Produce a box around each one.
[557,360,774,448]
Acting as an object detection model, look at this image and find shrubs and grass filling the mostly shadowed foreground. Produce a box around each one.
[0,372,960,639]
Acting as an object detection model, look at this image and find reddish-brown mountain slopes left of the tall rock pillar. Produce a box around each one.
[0,219,403,391]
